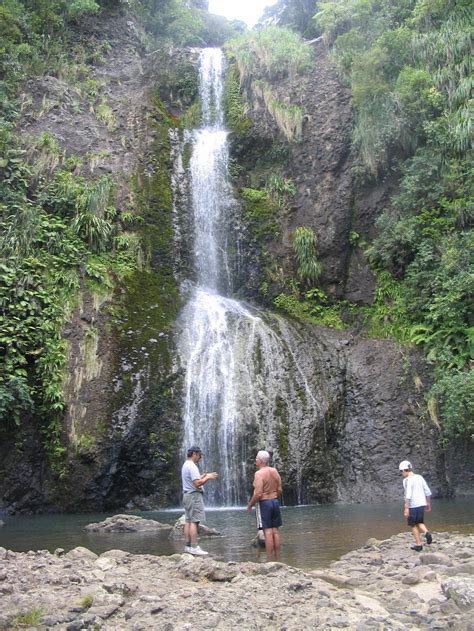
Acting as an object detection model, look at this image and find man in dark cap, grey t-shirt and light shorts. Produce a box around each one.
[181,447,218,556]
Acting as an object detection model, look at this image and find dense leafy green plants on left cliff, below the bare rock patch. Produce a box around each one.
[0,128,143,473]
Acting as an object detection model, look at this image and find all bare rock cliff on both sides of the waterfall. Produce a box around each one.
[0,11,472,511]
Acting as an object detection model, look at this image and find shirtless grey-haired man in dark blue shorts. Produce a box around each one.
[247,451,282,561]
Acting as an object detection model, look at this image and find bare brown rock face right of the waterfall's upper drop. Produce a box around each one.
[235,42,352,295]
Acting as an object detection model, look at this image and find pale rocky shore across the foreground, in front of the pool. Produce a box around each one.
[0,533,474,631]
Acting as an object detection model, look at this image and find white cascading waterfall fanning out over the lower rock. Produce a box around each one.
[178,49,320,506]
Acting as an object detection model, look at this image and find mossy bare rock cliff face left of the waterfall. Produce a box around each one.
[0,16,196,511]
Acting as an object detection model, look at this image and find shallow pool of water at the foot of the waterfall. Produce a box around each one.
[0,498,474,569]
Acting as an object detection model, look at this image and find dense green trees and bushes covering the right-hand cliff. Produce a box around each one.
[315,0,474,439]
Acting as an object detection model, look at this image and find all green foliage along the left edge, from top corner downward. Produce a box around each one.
[0,0,181,475]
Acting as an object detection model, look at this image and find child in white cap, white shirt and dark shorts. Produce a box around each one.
[398,460,433,552]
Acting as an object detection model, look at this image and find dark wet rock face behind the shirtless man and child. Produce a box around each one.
[252,324,444,504]
